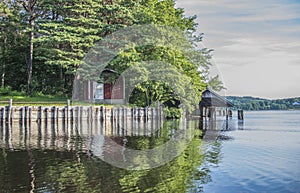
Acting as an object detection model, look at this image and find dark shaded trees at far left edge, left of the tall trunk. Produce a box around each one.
[0,1,28,90]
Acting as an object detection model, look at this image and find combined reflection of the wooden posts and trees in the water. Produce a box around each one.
[0,117,220,192]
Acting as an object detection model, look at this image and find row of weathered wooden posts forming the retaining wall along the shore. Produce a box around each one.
[0,100,164,122]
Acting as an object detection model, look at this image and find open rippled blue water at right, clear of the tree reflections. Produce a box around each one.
[200,111,300,192]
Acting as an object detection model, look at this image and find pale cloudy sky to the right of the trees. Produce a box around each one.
[176,0,300,99]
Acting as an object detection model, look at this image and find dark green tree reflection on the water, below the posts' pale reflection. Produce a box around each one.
[0,121,221,193]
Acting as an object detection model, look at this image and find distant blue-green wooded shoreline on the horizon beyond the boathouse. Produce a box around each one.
[226,96,300,110]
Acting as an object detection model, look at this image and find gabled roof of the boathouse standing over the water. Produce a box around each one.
[200,88,234,107]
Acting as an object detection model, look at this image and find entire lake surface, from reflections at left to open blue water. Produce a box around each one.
[0,111,300,193]
